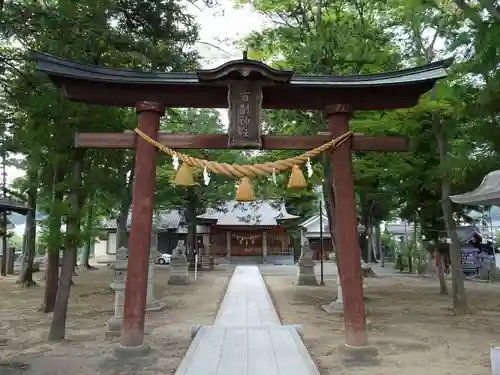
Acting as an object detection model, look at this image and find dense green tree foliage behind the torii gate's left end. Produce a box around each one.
[0,0,203,253]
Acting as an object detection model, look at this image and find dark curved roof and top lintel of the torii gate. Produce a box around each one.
[31,52,452,110]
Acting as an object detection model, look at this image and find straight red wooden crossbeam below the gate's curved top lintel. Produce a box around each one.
[75,132,409,152]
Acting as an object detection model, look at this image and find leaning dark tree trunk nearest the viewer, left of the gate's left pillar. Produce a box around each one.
[49,149,85,340]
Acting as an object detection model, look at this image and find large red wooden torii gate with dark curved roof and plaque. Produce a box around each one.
[32,52,451,355]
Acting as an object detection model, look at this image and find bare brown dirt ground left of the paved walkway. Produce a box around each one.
[0,268,231,375]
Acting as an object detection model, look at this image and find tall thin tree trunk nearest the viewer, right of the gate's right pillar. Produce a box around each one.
[432,111,468,315]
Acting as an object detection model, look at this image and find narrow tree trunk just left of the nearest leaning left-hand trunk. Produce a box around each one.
[43,167,64,313]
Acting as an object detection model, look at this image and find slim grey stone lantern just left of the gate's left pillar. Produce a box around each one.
[106,247,128,337]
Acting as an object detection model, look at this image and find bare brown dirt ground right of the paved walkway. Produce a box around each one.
[265,276,500,375]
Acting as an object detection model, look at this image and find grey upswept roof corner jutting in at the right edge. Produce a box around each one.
[450,170,500,206]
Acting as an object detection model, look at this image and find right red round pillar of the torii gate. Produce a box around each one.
[324,104,378,363]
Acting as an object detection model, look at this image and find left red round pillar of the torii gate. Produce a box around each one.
[115,102,165,357]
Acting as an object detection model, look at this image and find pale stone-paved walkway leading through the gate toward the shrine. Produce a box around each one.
[175,266,319,375]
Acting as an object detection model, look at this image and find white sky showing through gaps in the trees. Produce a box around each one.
[7,0,266,235]
